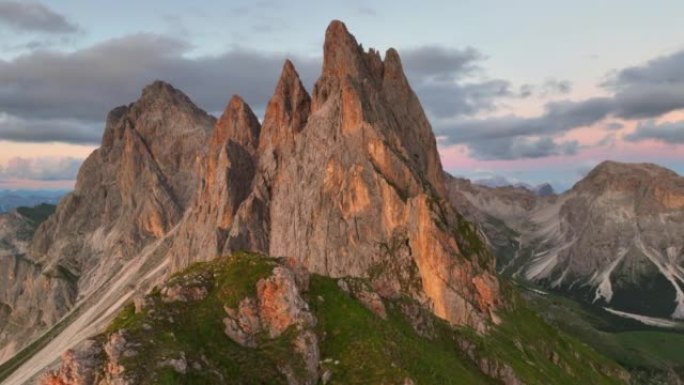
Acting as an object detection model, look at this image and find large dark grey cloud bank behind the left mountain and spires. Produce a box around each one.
[0,34,320,143]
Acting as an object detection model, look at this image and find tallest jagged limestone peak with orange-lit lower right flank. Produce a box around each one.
[268,22,498,325]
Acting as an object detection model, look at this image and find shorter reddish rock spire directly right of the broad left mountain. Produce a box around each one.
[171,96,266,269]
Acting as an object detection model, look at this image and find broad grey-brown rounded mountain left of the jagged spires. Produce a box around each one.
[0,82,214,364]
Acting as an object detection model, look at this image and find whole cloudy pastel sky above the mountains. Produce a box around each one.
[0,0,684,190]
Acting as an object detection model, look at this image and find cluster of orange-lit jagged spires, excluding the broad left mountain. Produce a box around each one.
[171,21,499,328]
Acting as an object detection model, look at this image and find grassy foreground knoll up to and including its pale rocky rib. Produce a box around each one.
[38,255,320,385]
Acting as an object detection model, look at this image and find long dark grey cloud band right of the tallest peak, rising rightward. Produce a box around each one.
[436,51,684,159]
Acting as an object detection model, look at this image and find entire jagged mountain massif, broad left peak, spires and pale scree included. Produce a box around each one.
[0,21,506,384]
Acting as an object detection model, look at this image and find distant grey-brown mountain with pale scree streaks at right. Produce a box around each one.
[450,162,684,318]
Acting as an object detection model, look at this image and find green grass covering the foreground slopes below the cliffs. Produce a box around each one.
[93,253,622,385]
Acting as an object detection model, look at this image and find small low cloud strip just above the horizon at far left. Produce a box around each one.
[0,157,83,181]
